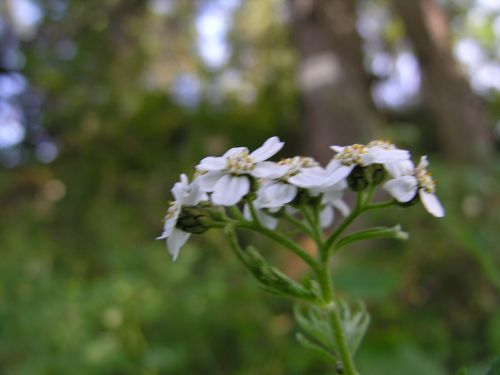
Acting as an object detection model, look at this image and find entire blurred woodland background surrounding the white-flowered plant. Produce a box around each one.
[0,0,500,375]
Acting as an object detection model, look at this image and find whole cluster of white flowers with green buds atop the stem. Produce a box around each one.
[159,137,444,260]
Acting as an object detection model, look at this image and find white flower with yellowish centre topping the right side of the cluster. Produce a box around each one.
[324,141,410,186]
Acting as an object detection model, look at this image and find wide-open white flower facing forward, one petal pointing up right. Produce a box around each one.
[196,137,288,206]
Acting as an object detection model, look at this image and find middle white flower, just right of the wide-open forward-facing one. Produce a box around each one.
[258,156,324,208]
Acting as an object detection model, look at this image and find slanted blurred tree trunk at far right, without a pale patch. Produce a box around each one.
[394,0,493,162]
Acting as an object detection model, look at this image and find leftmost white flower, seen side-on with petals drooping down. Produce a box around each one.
[157,174,208,261]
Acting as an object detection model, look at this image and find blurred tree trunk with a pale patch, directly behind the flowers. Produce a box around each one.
[289,0,378,162]
